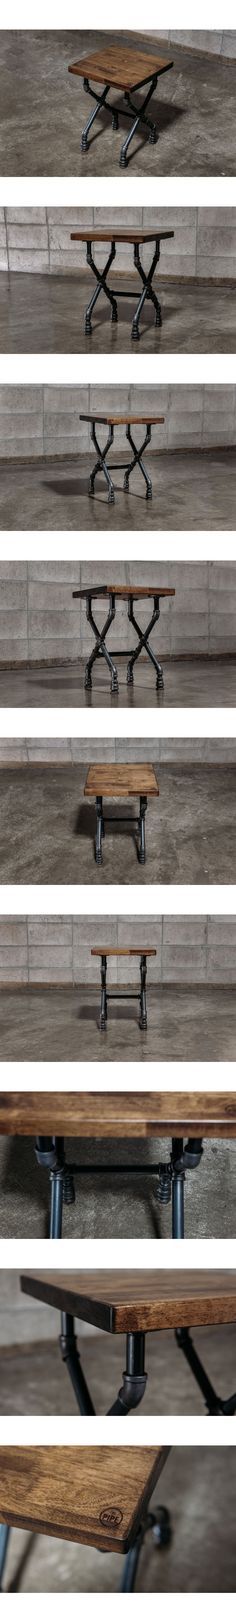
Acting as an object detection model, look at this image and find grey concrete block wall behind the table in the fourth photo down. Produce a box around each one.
[0,558,236,667]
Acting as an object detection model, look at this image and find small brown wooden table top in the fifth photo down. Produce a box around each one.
[84,764,158,798]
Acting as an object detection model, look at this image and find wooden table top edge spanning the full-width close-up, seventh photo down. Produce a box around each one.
[0,1091,236,1141]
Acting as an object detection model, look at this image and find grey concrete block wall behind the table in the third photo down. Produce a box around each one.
[0,383,236,461]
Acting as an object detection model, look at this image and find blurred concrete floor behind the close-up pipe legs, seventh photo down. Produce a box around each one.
[0,1137,236,1236]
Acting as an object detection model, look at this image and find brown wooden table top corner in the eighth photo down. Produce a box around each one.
[21,1270,236,1333]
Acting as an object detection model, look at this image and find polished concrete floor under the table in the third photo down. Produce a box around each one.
[0,448,236,532]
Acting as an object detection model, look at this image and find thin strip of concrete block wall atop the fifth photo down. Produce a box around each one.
[0,736,236,770]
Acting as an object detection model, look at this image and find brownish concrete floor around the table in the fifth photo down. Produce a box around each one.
[0,760,236,887]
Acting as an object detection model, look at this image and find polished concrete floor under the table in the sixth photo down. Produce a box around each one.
[0,974,236,1063]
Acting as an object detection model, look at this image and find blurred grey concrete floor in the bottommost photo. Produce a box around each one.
[3,1456,236,1594]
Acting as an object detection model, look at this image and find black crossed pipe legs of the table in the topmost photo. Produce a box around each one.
[81,73,159,168]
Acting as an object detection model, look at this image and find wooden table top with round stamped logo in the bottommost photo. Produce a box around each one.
[0,1445,168,1552]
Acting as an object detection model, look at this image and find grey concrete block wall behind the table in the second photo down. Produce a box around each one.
[0,207,236,285]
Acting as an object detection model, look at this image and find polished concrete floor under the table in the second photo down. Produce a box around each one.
[0,271,236,356]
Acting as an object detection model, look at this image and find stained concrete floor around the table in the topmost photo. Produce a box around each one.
[0,29,236,180]
